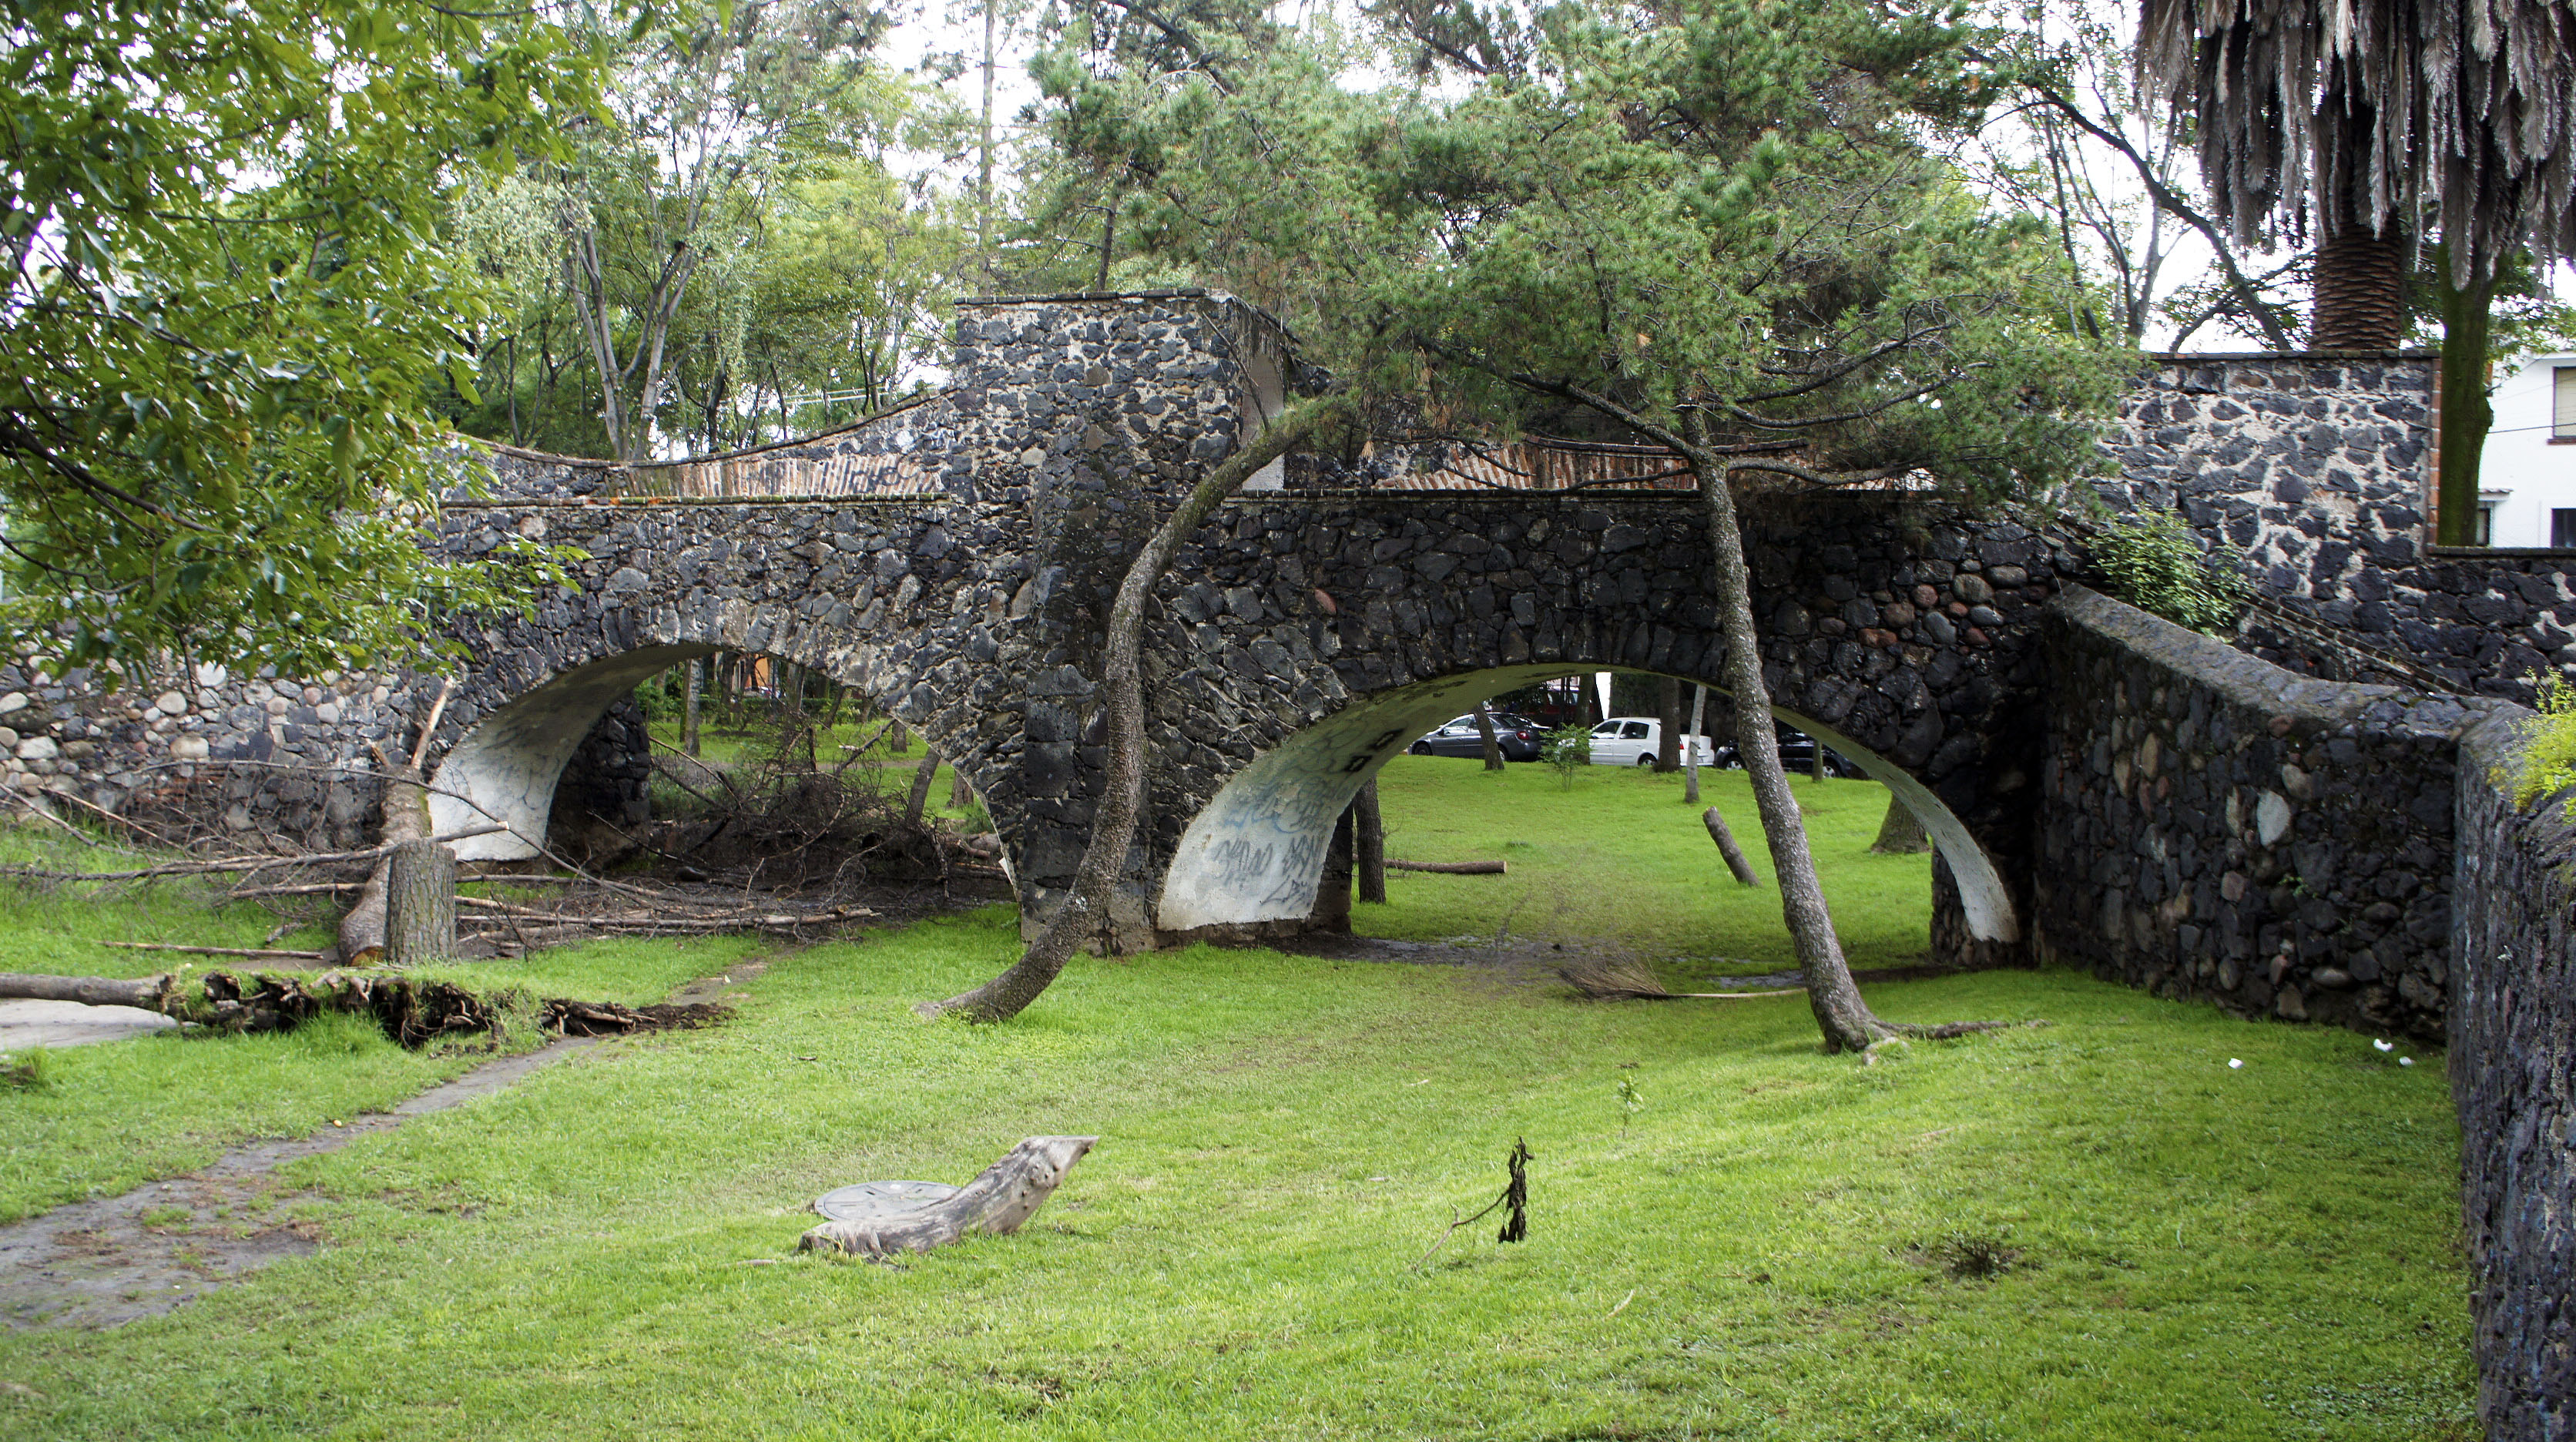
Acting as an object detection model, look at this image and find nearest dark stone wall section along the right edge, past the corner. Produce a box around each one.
[2450,706,2576,1442]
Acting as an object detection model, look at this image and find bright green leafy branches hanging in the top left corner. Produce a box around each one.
[0,0,595,672]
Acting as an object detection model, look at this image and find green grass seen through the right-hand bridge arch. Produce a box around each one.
[1353,757,1932,984]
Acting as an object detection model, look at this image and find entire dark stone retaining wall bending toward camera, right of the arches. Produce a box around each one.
[2035,587,2576,1442]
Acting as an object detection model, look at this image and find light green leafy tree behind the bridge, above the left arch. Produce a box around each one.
[456,0,966,461]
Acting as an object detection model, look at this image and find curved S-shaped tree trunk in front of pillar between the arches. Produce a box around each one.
[914,397,1353,1022]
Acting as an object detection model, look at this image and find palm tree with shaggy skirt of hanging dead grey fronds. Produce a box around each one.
[2138,0,2576,546]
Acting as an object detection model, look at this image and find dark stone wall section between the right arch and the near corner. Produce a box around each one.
[2035,587,2496,1038]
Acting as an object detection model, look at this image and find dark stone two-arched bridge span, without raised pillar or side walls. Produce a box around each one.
[435,491,2071,955]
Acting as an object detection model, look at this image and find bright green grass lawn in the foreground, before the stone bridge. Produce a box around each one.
[0,762,2476,1442]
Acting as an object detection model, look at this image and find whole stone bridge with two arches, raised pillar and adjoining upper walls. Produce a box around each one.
[20,291,2473,963]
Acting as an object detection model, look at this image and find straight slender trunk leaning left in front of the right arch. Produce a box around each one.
[1690,468,2001,1053]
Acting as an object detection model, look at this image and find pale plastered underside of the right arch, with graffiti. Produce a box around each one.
[1154,662,2022,942]
